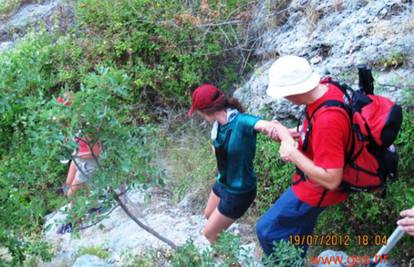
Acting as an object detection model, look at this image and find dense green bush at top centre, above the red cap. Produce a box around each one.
[77,0,254,107]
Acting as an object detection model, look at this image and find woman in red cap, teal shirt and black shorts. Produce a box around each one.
[188,84,272,243]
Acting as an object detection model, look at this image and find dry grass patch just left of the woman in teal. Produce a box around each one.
[157,122,216,209]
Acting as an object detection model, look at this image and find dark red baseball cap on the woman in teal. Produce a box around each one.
[188,84,225,117]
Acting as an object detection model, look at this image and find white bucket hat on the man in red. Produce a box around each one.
[266,56,321,98]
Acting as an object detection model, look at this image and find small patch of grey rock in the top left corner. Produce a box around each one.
[0,0,74,52]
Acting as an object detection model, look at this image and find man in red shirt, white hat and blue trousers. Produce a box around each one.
[256,56,351,257]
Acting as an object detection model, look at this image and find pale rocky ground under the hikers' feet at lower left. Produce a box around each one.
[44,190,252,266]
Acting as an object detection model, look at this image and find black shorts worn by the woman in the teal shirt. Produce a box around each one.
[213,182,256,220]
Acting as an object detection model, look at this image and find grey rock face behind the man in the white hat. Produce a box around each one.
[235,0,414,120]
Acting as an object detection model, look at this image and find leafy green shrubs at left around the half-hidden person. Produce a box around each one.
[0,44,159,261]
